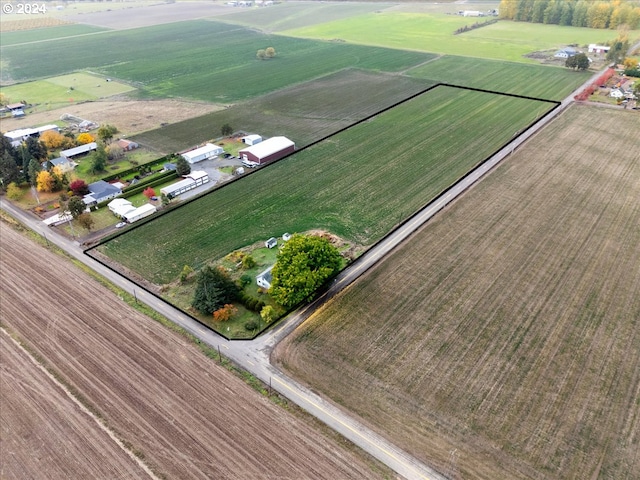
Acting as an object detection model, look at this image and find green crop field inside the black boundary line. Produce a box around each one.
[100,86,552,284]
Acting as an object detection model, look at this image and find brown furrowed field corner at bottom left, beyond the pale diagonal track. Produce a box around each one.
[0,331,150,480]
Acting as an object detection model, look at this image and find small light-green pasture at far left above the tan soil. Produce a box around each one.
[0,72,135,110]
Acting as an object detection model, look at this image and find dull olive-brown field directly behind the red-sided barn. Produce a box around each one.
[134,69,432,153]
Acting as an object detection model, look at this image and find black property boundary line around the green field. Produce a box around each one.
[83,83,561,341]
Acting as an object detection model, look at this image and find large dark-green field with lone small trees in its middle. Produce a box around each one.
[2,20,433,103]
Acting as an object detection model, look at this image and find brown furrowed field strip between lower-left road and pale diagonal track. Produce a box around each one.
[0,222,381,480]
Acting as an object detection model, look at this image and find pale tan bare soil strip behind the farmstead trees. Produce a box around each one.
[0,96,224,147]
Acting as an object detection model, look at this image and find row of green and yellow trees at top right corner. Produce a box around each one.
[500,0,640,29]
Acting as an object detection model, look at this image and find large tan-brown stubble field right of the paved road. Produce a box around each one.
[274,105,640,480]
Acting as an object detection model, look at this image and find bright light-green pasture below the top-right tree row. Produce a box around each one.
[282,11,628,63]
